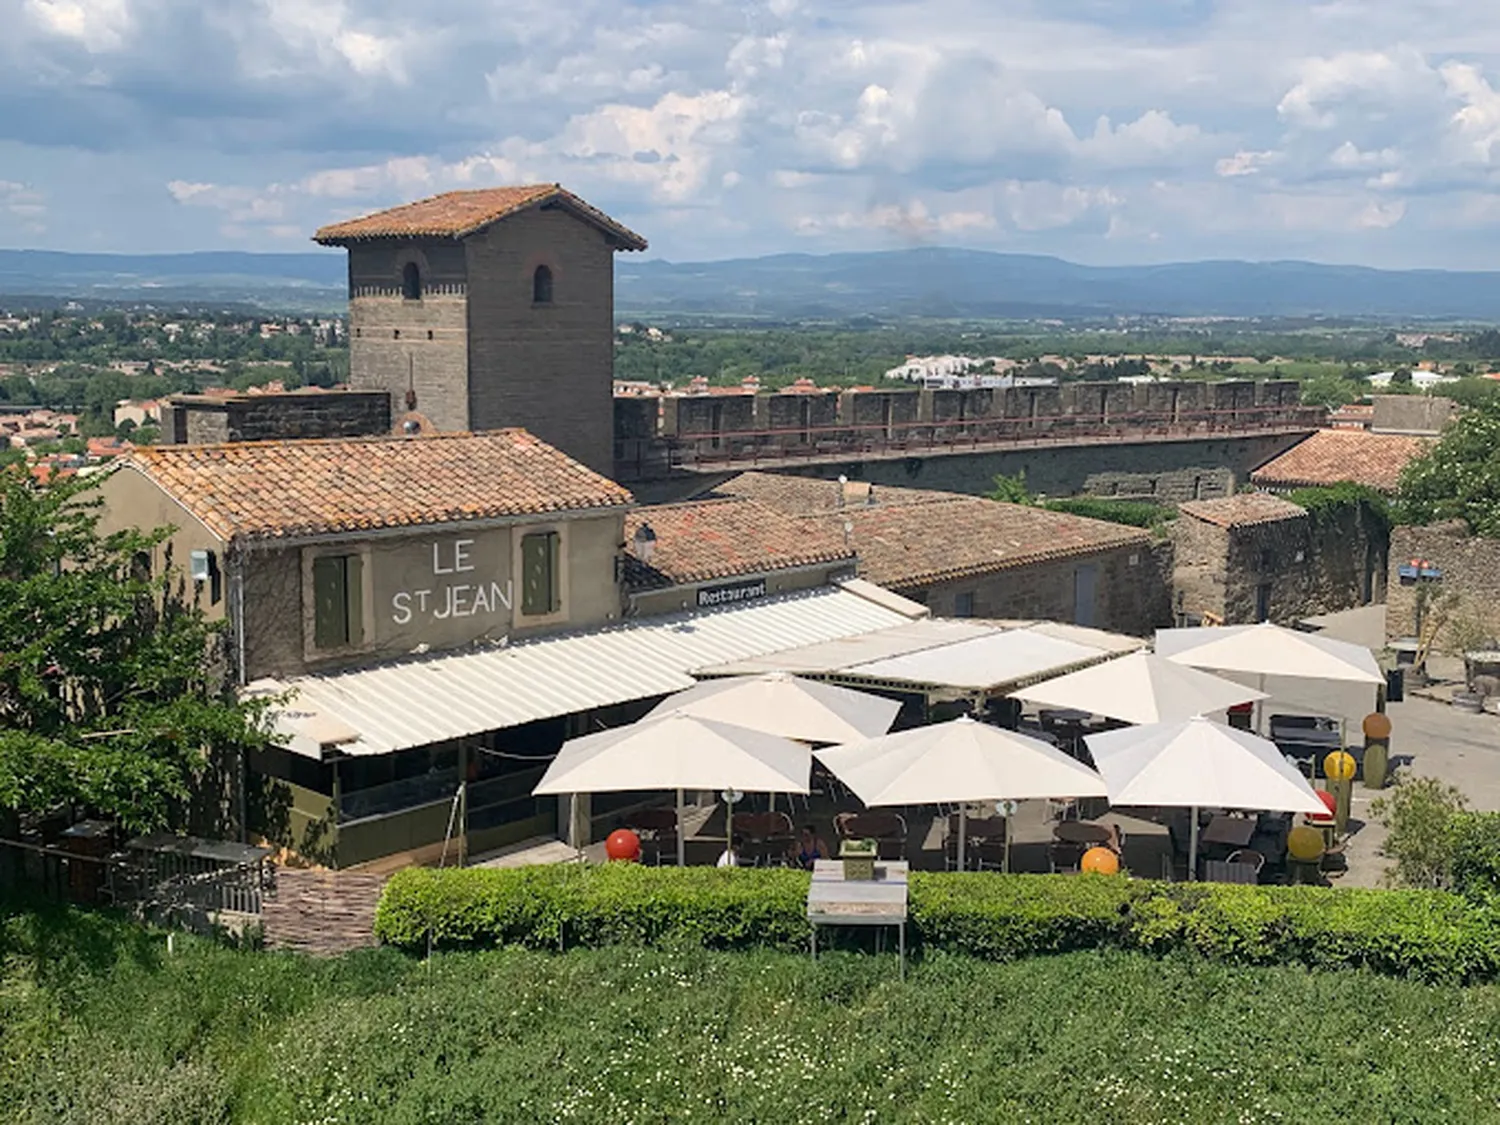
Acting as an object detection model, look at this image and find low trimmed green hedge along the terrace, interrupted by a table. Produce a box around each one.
[375,864,1500,981]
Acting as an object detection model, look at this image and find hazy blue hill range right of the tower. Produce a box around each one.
[615,249,1500,321]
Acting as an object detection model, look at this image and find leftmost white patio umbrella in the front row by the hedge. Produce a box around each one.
[531,711,813,864]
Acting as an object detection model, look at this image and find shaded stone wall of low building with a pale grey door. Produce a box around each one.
[897,542,1172,636]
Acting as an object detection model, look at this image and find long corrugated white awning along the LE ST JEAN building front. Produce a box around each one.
[248,587,926,758]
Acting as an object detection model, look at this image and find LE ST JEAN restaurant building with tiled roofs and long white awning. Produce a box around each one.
[102,429,926,867]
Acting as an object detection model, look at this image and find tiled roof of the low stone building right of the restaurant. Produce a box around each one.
[822,501,1151,590]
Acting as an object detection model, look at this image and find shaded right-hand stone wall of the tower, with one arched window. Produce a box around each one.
[464,207,615,474]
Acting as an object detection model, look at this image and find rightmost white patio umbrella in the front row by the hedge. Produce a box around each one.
[1083,717,1328,875]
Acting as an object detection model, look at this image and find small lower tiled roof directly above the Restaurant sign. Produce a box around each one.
[626,500,854,590]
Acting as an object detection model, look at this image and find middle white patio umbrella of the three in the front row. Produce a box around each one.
[813,716,1106,870]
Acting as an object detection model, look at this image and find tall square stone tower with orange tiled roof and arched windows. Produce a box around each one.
[314,185,647,474]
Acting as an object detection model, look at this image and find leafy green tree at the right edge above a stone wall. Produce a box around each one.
[1398,399,1500,539]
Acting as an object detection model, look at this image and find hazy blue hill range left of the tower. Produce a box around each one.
[0,251,348,309]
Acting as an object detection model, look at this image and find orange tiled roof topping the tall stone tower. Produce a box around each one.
[312,183,647,251]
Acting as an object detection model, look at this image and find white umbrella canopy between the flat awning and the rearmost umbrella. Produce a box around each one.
[1011,653,1266,723]
